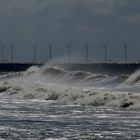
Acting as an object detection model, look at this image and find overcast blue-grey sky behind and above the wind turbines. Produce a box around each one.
[0,0,140,62]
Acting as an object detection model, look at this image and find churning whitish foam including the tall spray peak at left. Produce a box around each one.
[0,64,140,109]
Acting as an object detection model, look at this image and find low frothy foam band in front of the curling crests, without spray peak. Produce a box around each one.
[0,76,140,108]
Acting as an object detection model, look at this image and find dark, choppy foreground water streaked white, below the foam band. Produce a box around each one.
[0,100,140,140]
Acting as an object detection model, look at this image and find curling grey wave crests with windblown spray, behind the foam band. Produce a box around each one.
[25,66,128,86]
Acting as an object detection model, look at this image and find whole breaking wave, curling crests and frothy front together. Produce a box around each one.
[0,66,140,109]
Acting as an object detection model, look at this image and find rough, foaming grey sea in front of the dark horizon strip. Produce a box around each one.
[0,65,140,140]
